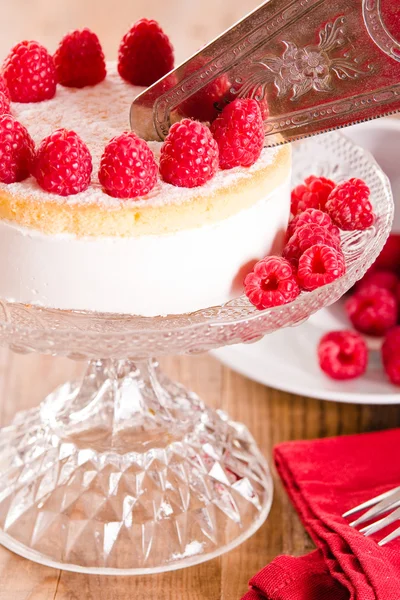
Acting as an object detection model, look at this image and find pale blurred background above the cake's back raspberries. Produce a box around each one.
[0,0,261,62]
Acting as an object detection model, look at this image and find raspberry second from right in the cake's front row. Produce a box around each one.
[160,119,218,188]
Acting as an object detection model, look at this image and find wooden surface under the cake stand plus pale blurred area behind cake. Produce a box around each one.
[0,0,400,600]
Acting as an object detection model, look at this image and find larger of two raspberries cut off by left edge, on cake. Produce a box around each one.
[0,115,35,183]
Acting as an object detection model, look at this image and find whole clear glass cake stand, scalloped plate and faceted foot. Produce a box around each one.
[0,133,393,575]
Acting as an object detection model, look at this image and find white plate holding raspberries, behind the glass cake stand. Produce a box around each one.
[213,118,400,404]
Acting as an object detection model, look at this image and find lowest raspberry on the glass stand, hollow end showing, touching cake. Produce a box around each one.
[244,256,300,310]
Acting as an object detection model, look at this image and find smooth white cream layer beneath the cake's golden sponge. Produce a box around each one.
[0,178,290,316]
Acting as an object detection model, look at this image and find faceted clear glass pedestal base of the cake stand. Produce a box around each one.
[0,360,272,575]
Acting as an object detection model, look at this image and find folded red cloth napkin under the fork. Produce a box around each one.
[243,429,400,600]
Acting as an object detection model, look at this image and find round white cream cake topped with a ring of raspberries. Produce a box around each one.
[0,20,291,316]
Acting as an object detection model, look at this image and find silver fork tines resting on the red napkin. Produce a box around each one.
[343,486,400,546]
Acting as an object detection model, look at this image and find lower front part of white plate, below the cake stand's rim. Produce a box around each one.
[213,305,400,404]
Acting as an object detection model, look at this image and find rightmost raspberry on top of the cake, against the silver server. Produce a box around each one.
[211,98,264,169]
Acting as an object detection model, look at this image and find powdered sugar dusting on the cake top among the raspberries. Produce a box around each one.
[0,63,277,208]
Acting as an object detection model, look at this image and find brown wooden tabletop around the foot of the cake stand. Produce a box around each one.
[0,350,400,600]
